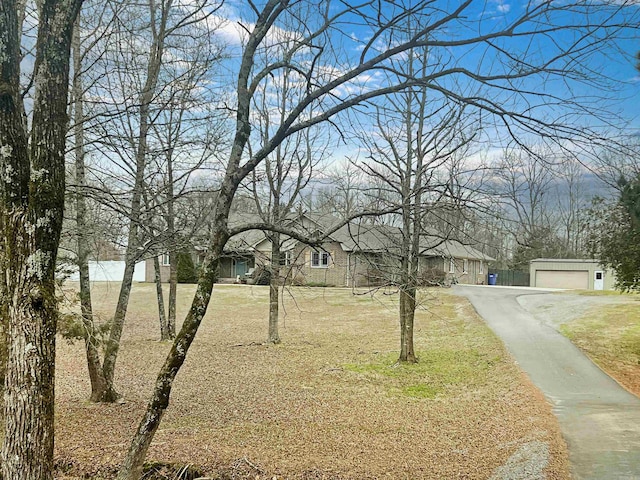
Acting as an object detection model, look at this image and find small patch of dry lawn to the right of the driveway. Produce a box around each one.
[561,295,640,396]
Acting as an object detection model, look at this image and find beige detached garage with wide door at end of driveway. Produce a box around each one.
[529,258,615,290]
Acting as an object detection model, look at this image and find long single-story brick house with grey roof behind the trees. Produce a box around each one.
[147,214,493,287]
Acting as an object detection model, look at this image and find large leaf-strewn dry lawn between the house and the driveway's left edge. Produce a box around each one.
[56,284,568,480]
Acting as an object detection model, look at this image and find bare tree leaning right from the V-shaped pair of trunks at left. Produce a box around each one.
[70,0,219,402]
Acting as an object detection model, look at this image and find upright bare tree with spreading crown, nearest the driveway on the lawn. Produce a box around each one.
[363,39,473,363]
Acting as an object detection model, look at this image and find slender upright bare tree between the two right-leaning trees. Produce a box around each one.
[148,49,222,340]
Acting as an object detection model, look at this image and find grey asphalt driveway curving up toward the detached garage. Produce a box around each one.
[454,285,640,480]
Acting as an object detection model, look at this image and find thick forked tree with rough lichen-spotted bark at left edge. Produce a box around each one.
[0,0,82,480]
